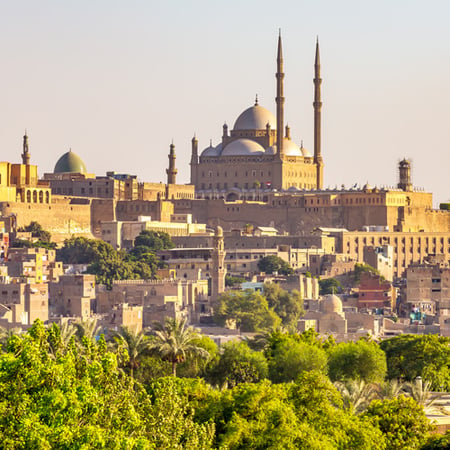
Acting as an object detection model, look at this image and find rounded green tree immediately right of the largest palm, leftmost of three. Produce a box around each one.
[207,341,268,387]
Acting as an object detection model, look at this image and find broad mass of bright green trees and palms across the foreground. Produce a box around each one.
[0,320,448,450]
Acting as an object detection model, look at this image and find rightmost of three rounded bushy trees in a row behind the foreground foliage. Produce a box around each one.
[328,339,386,383]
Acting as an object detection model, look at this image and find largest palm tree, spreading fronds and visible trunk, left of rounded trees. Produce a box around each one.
[151,317,209,377]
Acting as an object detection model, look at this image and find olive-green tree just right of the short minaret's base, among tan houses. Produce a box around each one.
[214,290,281,332]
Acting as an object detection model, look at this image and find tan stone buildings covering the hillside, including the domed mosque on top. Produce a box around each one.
[0,37,450,339]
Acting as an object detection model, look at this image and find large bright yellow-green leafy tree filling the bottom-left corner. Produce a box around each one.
[0,321,214,450]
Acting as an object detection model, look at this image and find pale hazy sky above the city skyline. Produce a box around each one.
[0,0,450,206]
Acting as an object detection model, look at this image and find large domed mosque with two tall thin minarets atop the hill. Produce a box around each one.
[190,35,324,201]
